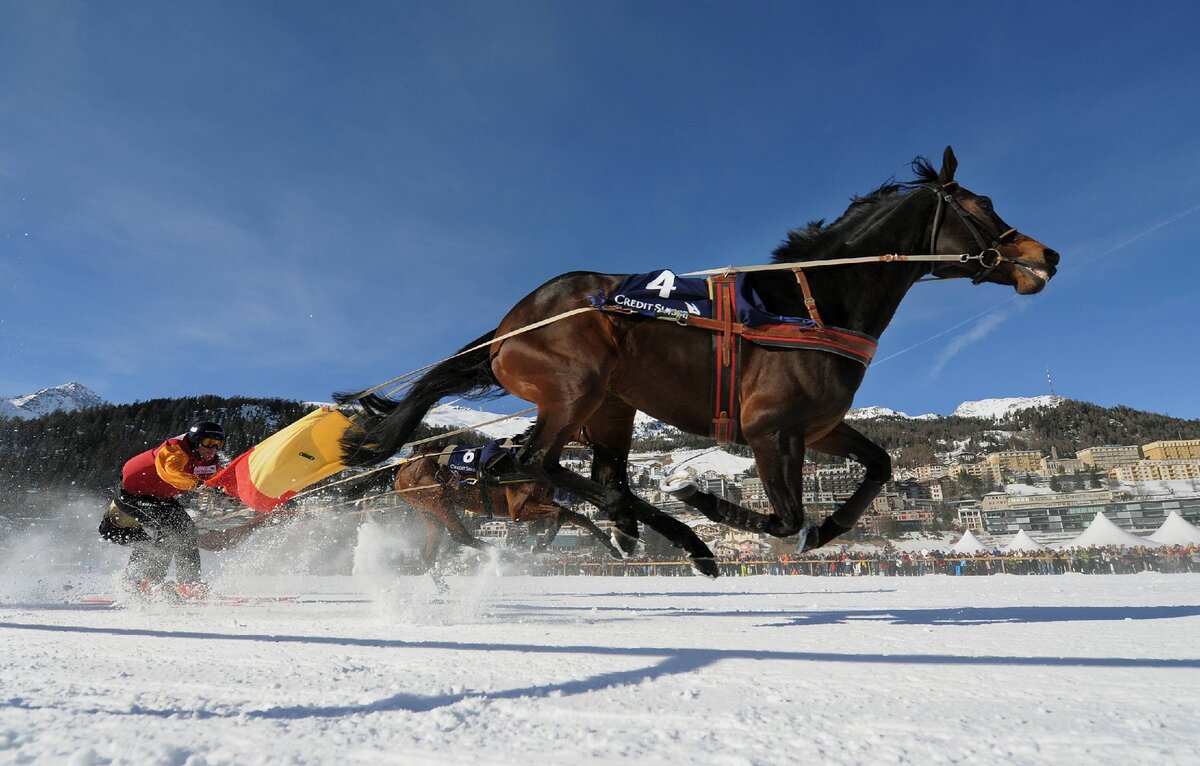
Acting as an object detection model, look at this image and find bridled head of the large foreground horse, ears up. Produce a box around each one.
[926,146,1058,295]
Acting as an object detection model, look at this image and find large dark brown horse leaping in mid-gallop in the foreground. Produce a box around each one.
[341,146,1058,576]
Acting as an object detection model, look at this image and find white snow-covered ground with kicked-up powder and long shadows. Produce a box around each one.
[0,504,1200,766]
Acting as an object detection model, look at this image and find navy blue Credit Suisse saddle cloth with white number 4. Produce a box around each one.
[592,269,817,327]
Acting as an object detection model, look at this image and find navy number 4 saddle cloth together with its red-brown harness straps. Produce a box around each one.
[588,268,878,443]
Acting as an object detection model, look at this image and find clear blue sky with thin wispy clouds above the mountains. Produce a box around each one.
[0,0,1200,418]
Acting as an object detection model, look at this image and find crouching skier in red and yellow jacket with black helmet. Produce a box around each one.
[100,420,224,598]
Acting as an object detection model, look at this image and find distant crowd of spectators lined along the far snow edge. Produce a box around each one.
[529,545,1200,578]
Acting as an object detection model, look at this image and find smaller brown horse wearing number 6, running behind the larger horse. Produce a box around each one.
[395,446,620,570]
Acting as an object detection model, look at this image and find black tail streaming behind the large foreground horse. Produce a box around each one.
[335,330,499,466]
